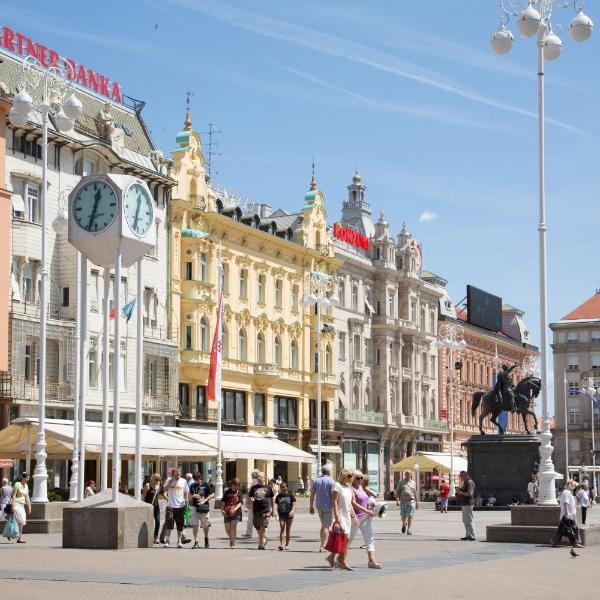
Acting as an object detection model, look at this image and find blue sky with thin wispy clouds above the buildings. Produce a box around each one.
[2,0,600,408]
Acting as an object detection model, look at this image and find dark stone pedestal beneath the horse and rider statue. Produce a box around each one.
[463,434,540,506]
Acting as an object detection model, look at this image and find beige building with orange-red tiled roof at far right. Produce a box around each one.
[550,291,600,473]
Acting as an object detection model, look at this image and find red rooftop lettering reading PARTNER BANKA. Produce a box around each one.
[0,27,121,103]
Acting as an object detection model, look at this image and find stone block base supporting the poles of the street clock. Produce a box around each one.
[63,489,154,550]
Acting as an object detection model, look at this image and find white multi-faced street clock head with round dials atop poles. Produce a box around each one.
[69,174,156,267]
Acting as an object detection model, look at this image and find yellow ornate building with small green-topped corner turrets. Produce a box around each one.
[169,114,341,489]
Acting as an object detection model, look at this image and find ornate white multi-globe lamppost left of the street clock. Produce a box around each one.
[8,56,83,502]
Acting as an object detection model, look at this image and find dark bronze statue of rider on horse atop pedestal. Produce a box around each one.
[471,364,542,435]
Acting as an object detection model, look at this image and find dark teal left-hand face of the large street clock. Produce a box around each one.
[72,181,118,233]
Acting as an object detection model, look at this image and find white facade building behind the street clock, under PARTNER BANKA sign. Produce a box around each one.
[0,47,178,487]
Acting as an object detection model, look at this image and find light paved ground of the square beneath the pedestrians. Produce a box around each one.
[0,507,600,600]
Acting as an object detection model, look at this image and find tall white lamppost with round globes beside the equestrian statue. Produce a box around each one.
[490,0,594,505]
